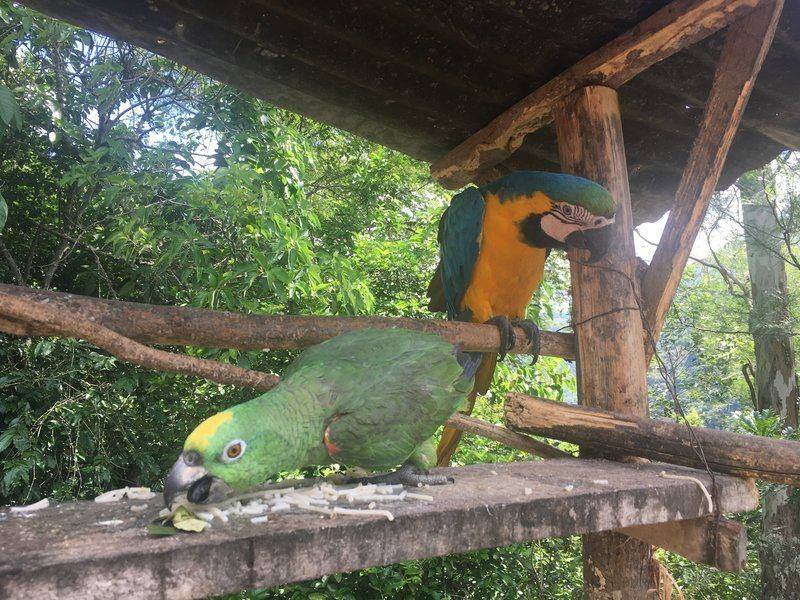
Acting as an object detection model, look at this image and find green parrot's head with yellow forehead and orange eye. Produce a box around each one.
[164,401,286,507]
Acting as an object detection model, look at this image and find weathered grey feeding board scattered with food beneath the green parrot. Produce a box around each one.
[0,460,757,600]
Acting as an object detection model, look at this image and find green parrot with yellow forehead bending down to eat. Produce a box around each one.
[159,329,481,506]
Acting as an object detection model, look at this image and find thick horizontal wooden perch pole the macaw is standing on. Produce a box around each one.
[0,284,574,360]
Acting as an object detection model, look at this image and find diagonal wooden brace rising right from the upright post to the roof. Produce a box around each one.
[642,0,783,352]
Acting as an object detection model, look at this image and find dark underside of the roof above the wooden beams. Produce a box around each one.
[17,0,800,222]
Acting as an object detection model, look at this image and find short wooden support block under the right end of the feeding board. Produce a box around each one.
[620,516,747,572]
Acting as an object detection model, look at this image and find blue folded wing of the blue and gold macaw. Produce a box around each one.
[428,187,486,321]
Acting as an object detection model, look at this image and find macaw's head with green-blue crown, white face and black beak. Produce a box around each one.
[486,171,616,262]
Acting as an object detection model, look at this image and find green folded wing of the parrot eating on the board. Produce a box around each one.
[284,329,475,469]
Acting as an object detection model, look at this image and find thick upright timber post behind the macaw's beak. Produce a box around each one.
[553,86,652,600]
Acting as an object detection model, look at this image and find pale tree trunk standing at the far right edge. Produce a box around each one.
[742,205,800,600]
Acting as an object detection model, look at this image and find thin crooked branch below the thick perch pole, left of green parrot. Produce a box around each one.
[0,291,279,391]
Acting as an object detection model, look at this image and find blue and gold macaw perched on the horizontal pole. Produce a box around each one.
[428,171,615,466]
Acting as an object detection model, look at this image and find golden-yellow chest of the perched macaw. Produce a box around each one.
[461,192,551,323]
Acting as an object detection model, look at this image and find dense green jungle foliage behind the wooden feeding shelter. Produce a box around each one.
[0,1,800,599]
